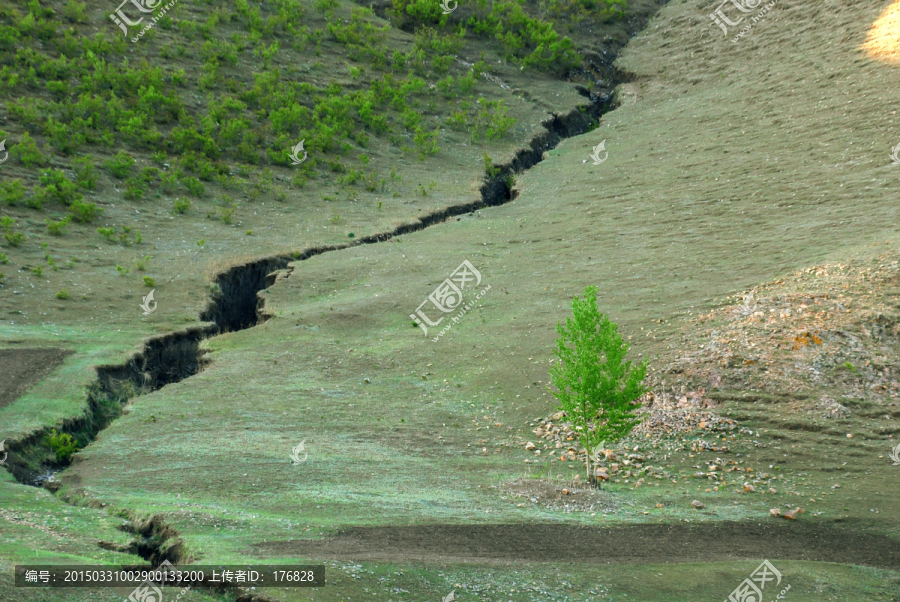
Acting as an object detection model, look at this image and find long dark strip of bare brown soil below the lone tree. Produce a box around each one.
[252,518,900,570]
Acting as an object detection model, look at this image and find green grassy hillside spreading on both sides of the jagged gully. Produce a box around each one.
[0,0,900,601]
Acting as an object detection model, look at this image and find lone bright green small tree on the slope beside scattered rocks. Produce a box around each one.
[550,286,648,482]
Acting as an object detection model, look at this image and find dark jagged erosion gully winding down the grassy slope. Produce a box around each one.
[5,47,632,576]
